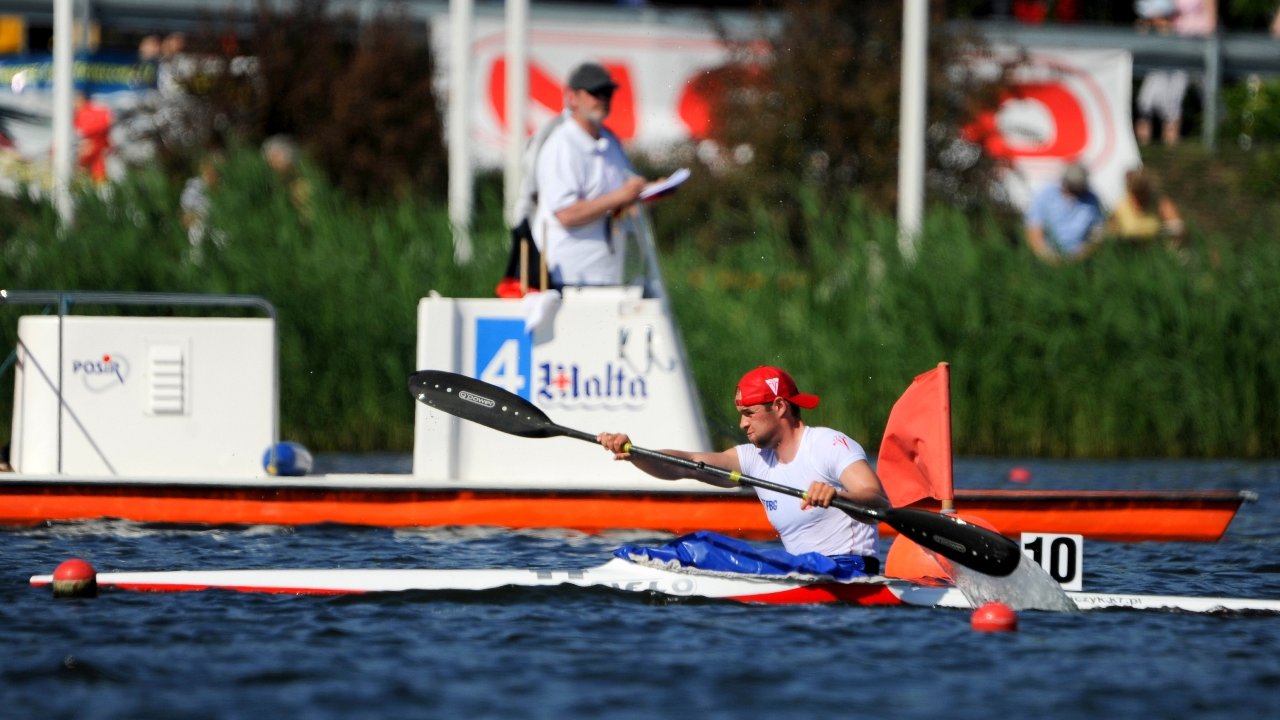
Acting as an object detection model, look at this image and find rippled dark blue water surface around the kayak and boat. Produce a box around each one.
[0,460,1280,720]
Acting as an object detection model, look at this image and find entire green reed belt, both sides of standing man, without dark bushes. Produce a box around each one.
[0,151,1280,457]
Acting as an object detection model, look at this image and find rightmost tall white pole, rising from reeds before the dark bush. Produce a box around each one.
[897,0,929,260]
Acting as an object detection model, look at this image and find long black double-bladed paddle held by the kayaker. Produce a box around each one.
[408,370,1023,577]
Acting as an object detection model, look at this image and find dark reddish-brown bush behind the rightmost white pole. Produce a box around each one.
[675,0,1002,251]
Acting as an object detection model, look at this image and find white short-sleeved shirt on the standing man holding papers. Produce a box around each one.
[531,119,635,284]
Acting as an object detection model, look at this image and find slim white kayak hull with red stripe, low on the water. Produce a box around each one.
[31,559,1280,614]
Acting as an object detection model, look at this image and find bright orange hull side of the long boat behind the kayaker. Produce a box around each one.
[0,484,1242,542]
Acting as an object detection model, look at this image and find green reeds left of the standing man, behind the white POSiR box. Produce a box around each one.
[0,151,507,451]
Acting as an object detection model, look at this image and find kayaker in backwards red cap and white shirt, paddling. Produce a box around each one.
[596,366,888,575]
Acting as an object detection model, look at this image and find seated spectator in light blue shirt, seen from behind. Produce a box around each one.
[1027,163,1105,263]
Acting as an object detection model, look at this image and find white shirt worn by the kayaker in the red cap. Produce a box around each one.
[737,425,879,556]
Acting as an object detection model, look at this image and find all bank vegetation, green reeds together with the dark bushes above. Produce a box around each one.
[0,0,1280,457]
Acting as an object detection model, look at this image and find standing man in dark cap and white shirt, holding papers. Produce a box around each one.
[532,63,645,287]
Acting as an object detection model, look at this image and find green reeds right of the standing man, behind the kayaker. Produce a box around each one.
[666,190,1280,457]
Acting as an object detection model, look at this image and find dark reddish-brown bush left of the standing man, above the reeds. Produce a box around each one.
[192,0,448,199]
